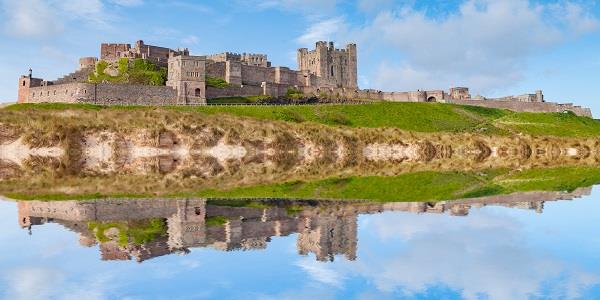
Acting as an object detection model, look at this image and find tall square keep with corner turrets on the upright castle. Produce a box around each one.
[298,41,358,89]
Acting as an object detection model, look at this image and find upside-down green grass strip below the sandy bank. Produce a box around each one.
[6,167,600,203]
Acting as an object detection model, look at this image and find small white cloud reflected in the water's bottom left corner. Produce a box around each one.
[3,267,116,300]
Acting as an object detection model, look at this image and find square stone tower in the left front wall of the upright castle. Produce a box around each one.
[167,55,206,104]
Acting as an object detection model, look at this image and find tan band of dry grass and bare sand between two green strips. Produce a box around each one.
[0,112,600,194]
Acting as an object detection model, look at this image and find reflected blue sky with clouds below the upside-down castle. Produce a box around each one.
[0,188,600,300]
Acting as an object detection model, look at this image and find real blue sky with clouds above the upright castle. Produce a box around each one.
[0,0,600,116]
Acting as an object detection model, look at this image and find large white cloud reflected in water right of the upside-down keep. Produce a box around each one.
[350,213,600,299]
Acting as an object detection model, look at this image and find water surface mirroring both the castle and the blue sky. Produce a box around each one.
[0,188,600,299]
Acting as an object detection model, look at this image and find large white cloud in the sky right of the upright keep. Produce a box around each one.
[297,0,600,92]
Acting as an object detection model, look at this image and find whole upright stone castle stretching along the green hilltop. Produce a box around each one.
[18,41,592,117]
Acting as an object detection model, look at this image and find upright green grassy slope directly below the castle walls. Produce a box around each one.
[5,99,600,137]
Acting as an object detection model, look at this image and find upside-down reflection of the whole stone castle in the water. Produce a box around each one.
[18,188,591,262]
